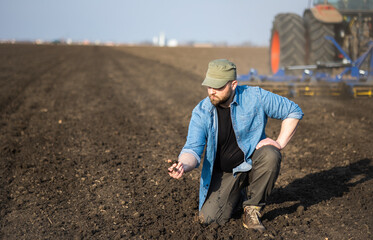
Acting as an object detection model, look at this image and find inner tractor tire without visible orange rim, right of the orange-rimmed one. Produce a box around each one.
[303,11,336,64]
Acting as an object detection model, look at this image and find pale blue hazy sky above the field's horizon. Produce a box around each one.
[0,0,309,46]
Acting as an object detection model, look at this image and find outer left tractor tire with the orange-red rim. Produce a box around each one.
[269,13,305,74]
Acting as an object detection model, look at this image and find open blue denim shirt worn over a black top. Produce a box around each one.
[180,86,303,210]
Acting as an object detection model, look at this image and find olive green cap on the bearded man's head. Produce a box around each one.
[202,59,237,88]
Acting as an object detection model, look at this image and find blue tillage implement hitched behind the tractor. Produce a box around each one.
[237,37,373,97]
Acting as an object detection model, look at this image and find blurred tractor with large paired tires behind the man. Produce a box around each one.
[269,0,373,74]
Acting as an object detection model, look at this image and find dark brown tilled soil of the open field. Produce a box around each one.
[0,45,373,240]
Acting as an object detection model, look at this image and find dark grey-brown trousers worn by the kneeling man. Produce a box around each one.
[199,146,282,224]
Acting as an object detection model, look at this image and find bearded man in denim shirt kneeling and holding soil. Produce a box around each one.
[168,59,303,231]
